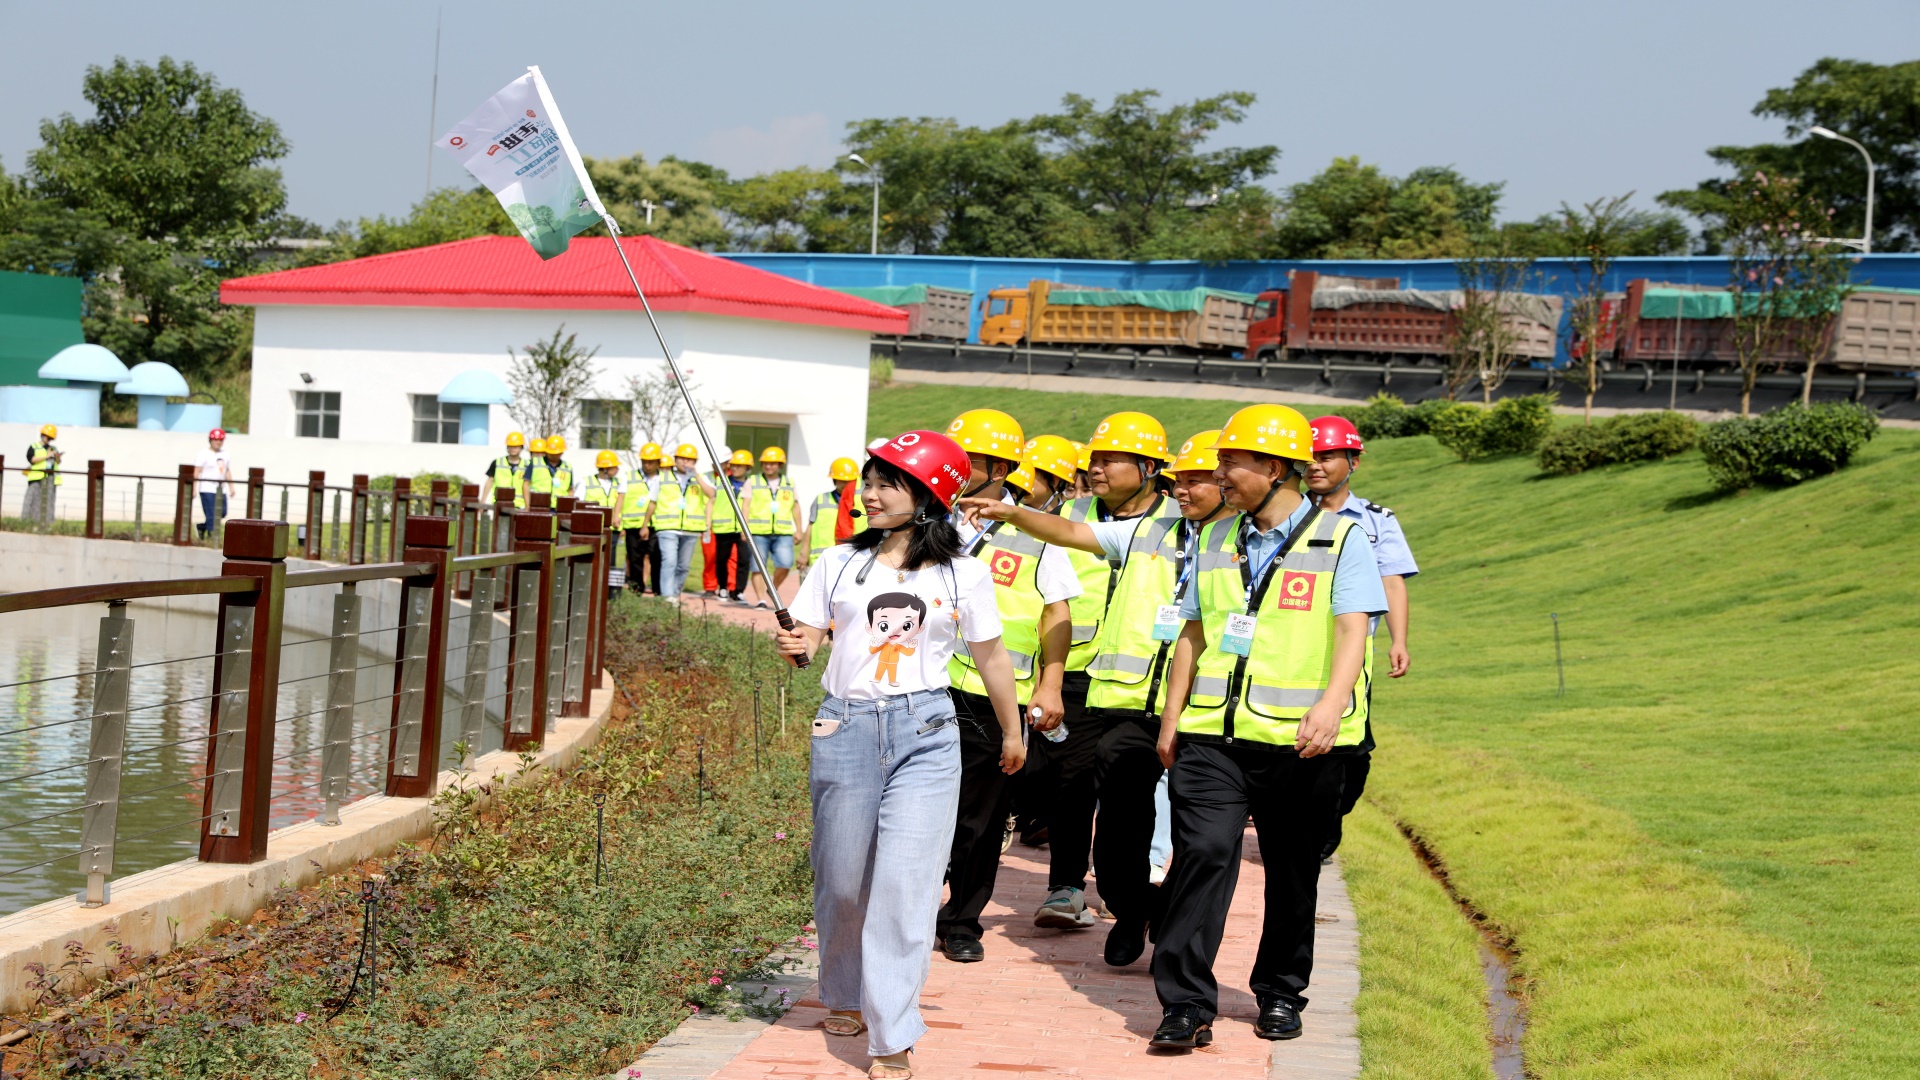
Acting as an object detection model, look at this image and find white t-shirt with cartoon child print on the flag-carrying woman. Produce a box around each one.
[793,544,1000,701]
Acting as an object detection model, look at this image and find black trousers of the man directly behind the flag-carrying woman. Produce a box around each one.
[935,690,1014,938]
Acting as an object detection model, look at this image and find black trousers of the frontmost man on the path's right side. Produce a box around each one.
[1154,742,1344,1019]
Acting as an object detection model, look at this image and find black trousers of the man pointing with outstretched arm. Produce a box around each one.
[1089,713,1165,922]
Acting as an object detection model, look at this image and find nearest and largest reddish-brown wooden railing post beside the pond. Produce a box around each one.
[200,519,288,863]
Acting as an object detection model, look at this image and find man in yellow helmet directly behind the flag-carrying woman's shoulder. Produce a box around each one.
[935,409,1081,963]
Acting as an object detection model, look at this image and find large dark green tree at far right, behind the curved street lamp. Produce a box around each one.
[1661,58,1920,252]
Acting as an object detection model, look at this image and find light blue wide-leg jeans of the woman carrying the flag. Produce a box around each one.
[812,690,960,1057]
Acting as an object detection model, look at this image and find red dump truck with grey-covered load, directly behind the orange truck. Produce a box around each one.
[1246,271,1561,359]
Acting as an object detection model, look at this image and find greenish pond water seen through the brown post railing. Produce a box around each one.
[0,601,503,915]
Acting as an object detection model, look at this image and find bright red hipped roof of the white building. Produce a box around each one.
[221,236,906,334]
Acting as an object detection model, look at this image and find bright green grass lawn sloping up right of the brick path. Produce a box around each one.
[870,386,1920,1078]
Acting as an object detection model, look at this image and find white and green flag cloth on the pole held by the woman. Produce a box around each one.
[440,67,607,259]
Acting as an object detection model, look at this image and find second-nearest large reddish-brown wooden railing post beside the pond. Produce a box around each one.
[386,517,453,799]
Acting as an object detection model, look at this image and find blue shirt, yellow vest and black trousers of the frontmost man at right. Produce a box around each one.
[1152,502,1386,1022]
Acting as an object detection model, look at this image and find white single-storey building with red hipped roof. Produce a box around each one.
[221,236,906,492]
